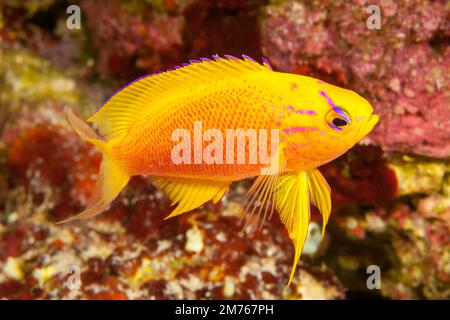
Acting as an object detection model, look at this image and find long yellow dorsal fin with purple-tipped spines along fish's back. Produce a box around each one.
[88,56,271,140]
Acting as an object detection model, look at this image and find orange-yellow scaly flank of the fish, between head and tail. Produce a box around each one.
[114,75,283,180]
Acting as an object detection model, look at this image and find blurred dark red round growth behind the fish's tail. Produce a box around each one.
[3,109,100,219]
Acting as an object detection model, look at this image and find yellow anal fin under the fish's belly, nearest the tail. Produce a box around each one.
[153,177,230,219]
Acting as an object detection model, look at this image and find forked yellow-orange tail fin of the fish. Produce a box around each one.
[58,109,130,223]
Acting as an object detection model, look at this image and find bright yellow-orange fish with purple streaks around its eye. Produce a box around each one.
[66,56,378,285]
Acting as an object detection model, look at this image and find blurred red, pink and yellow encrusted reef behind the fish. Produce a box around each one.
[0,0,450,299]
